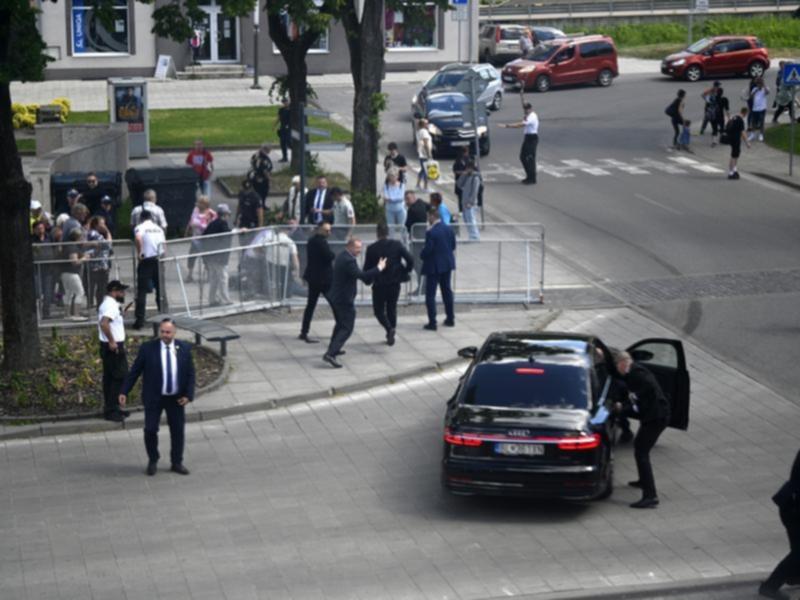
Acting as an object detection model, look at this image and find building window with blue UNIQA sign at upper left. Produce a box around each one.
[71,0,130,56]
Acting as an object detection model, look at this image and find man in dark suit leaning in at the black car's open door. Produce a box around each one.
[614,352,670,508]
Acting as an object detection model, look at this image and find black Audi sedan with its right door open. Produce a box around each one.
[442,332,689,500]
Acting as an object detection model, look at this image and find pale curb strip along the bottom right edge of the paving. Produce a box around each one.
[478,573,769,600]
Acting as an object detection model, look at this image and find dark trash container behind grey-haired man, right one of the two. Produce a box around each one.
[125,167,197,235]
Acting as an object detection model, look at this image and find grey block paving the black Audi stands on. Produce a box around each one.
[0,309,800,600]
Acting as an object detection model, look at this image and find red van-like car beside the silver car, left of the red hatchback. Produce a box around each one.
[503,35,619,92]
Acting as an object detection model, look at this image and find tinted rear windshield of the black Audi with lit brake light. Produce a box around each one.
[463,361,589,409]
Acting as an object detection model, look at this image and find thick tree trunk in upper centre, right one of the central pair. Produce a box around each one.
[342,0,384,194]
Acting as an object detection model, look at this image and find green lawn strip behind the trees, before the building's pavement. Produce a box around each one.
[20,106,353,152]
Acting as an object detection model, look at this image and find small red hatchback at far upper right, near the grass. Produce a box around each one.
[661,35,769,81]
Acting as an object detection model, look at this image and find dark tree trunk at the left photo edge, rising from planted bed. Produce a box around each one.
[0,83,39,372]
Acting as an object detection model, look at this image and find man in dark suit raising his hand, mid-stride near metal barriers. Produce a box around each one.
[322,238,386,369]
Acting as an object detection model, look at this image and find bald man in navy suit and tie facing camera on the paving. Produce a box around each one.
[119,318,194,475]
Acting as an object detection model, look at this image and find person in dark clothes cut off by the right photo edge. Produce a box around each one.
[758,450,800,600]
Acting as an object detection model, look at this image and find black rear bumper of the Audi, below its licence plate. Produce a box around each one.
[442,459,605,500]
